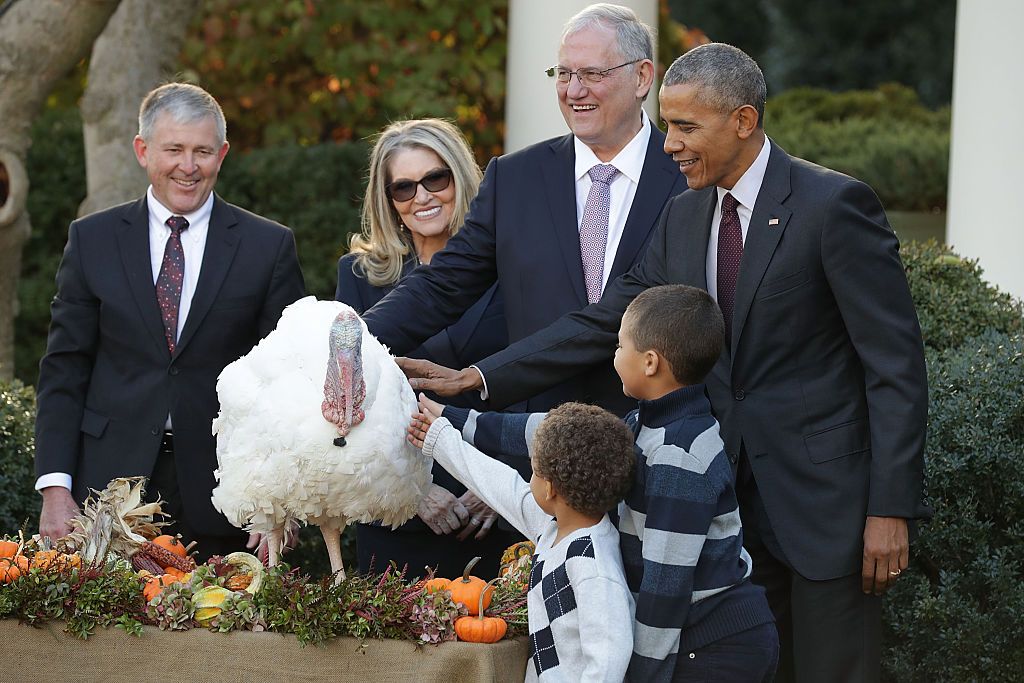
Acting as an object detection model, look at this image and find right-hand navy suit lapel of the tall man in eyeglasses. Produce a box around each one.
[608,122,680,282]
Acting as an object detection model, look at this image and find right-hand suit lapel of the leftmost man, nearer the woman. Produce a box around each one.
[174,196,241,357]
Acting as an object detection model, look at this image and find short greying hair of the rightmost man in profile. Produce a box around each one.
[662,43,768,128]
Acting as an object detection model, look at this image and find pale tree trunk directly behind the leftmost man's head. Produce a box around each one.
[78,0,201,216]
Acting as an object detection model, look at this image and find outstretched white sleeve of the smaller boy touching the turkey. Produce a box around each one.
[423,418,552,540]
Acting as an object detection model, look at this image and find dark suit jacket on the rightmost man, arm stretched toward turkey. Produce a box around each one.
[468,144,931,580]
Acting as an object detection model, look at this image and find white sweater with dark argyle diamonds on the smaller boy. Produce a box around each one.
[423,418,633,683]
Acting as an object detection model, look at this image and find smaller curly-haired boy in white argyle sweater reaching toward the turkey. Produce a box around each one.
[409,403,635,683]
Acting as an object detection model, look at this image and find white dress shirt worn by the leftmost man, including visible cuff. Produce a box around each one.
[36,185,213,490]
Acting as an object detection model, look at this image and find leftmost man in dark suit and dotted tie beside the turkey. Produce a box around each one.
[36,83,304,557]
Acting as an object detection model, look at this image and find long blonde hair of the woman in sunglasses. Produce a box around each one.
[348,119,483,287]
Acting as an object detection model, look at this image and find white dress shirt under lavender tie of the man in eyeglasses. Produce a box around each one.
[572,110,650,291]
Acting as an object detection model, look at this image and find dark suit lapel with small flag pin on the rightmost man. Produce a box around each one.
[730,142,793,357]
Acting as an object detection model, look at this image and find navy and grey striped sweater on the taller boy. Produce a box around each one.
[444,384,773,682]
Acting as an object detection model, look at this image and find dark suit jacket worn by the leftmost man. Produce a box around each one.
[36,197,304,536]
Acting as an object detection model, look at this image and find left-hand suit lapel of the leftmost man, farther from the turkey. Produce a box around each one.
[117,197,170,357]
